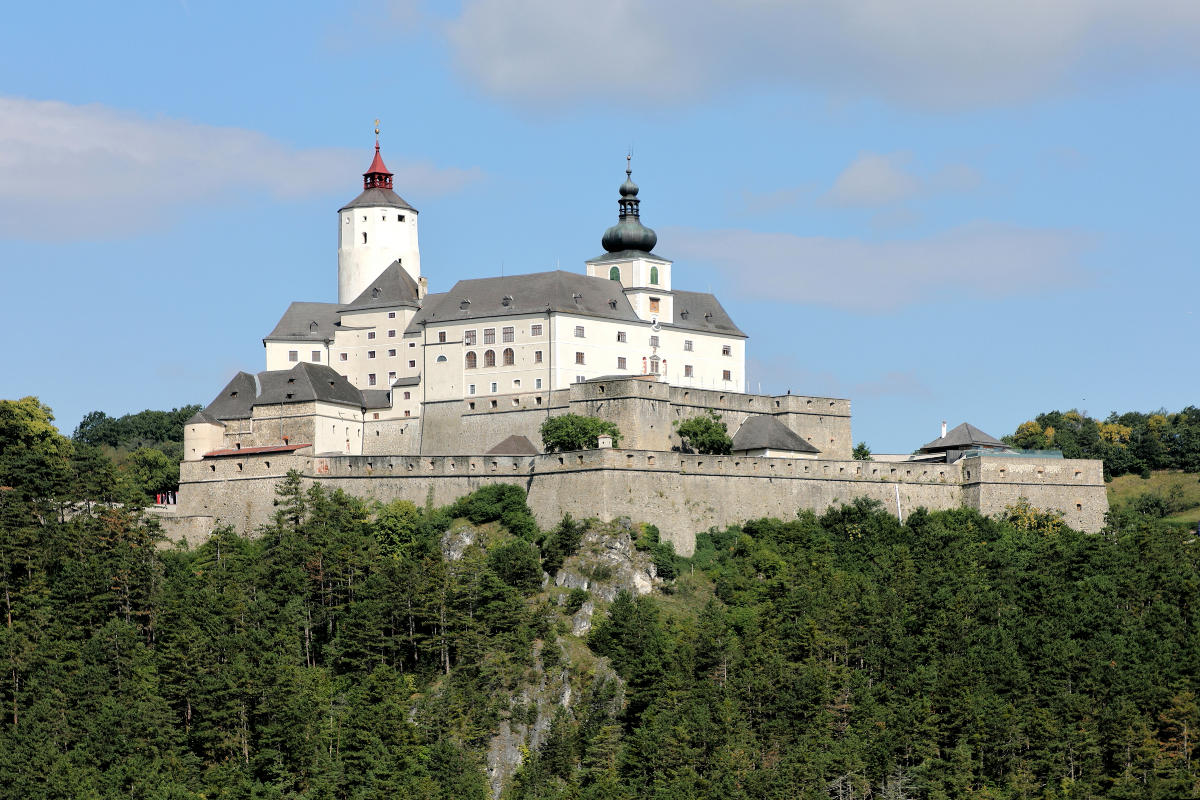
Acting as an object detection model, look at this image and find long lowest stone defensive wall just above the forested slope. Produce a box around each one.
[164,449,1108,555]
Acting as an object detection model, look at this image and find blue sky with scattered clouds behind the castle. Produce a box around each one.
[0,0,1200,452]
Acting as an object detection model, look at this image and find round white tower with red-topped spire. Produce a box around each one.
[337,134,421,303]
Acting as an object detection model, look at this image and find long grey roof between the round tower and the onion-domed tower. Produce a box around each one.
[419,270,641,323]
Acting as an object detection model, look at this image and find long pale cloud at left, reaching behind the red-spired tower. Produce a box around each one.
[0,97,480,239]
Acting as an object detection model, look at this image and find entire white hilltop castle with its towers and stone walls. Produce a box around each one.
[166,139,1108,554]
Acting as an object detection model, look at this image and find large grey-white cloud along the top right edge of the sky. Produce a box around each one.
[445,0,1200,107]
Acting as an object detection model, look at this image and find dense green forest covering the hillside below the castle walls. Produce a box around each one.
[0,401,1200,800]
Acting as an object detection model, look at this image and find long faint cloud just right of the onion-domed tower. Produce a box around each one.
[659,222,1090,311]
